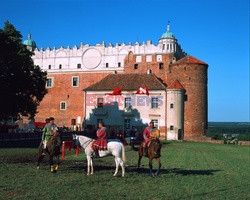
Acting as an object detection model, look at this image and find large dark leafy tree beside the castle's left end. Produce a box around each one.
[0,21,47,121]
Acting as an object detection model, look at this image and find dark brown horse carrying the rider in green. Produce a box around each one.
[37,131,61,173]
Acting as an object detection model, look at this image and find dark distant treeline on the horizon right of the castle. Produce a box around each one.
[207,122,250,141]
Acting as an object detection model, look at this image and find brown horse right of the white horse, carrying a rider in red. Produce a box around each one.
[138,139,161,176]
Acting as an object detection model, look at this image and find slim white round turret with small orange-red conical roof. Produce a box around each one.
[166,80,185,140]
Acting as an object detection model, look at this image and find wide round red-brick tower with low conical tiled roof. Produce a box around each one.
[168,56,208,140]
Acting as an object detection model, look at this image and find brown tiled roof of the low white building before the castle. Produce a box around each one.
[84,74,166,91]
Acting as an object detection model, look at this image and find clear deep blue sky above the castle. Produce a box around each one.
[0,0,249,122]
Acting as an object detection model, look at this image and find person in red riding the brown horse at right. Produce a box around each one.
[143,121,160,156]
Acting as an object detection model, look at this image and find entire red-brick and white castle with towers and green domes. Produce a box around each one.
[24,25,208,140]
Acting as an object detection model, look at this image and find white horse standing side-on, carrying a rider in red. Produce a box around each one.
[73,135,126,177]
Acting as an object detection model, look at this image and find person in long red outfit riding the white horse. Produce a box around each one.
[93,122,107,157]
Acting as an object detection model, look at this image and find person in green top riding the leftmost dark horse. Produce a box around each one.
[42,117,58,155]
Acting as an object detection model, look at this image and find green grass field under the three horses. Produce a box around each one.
[0,142,250,200]
